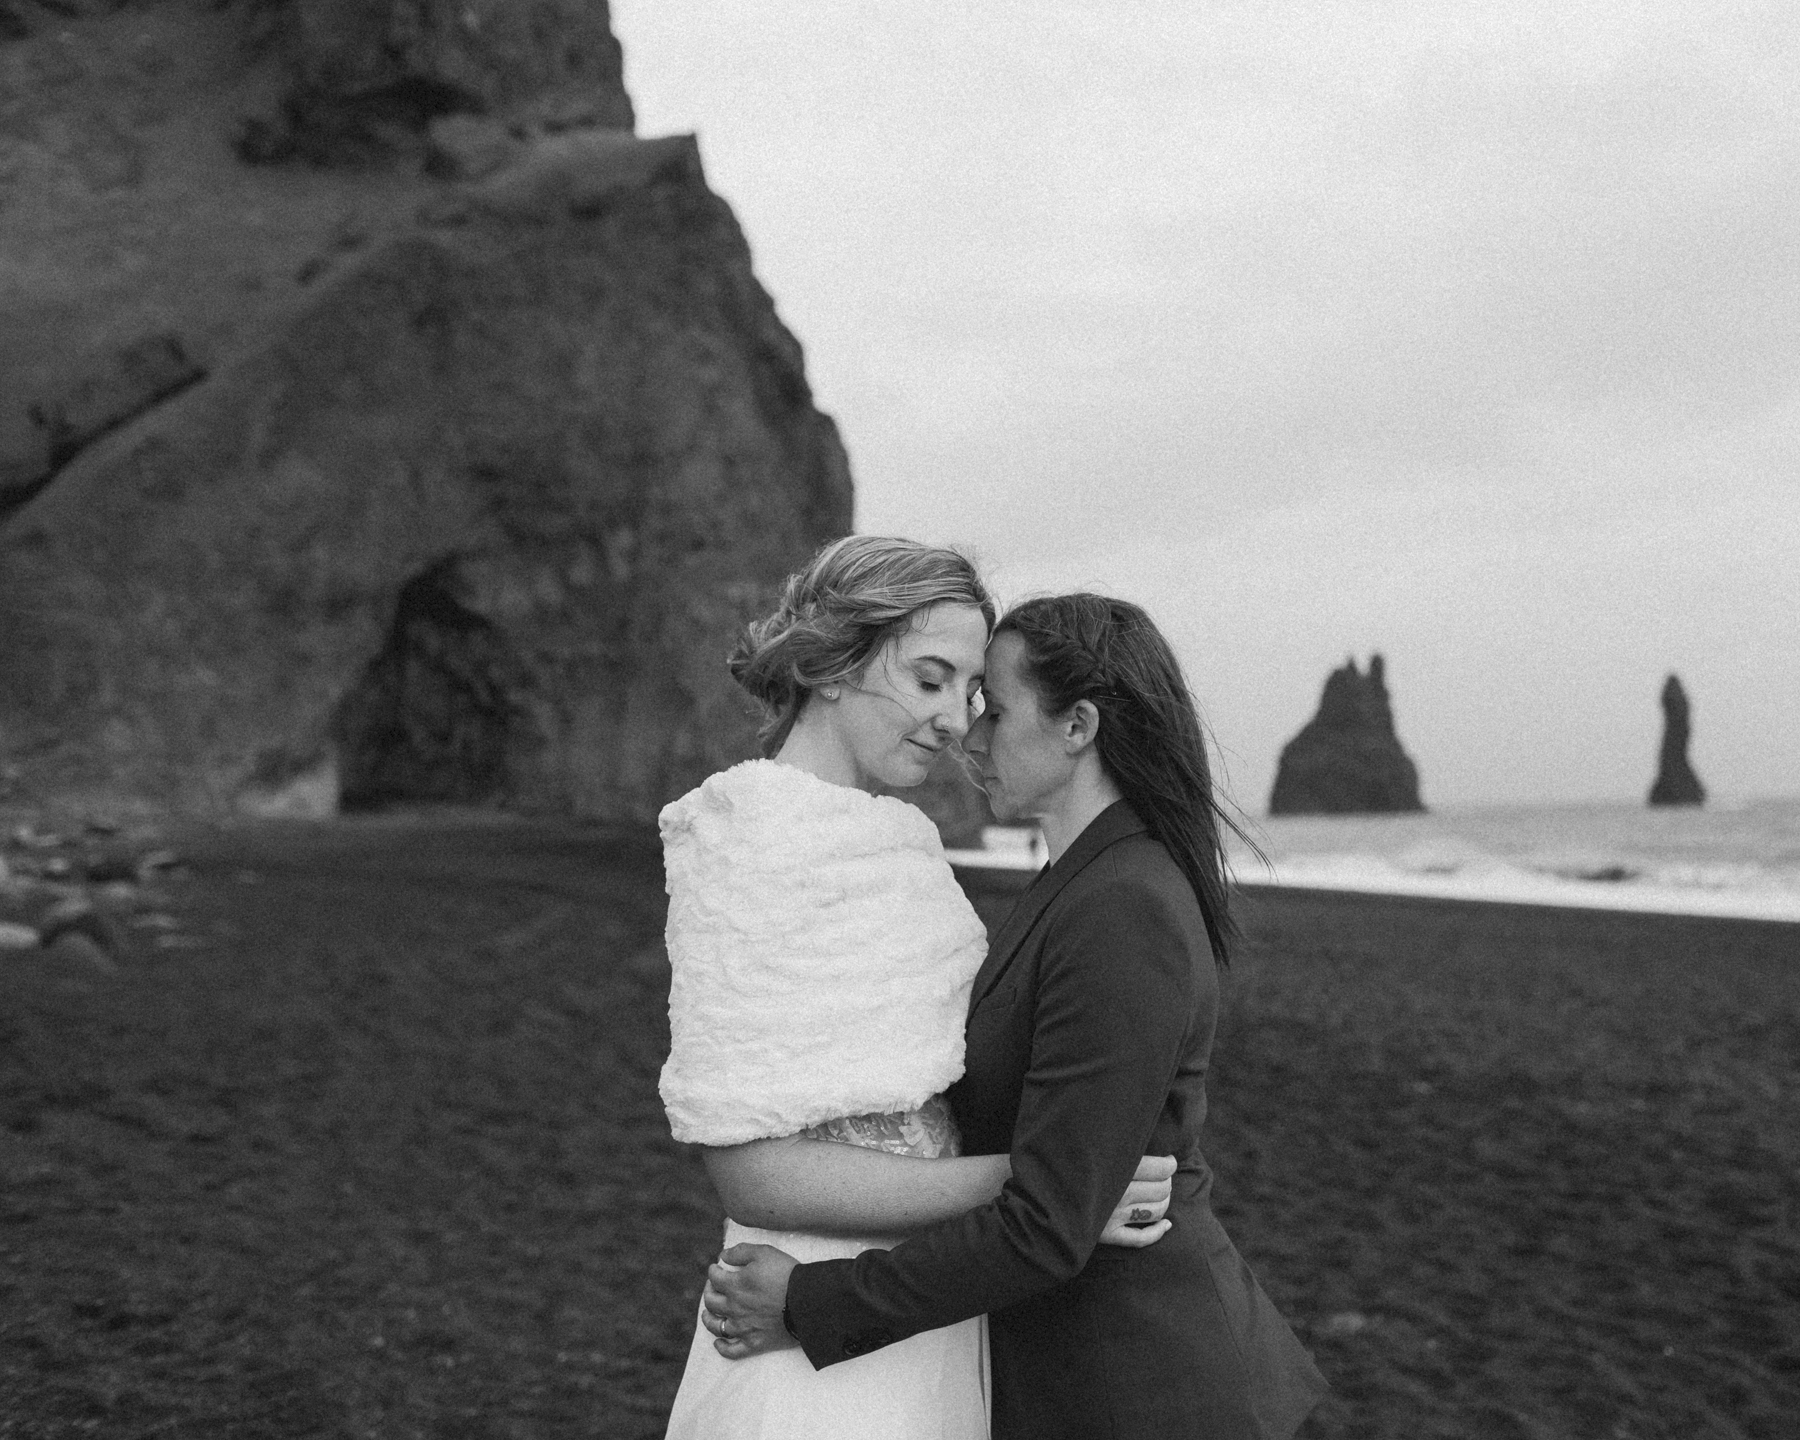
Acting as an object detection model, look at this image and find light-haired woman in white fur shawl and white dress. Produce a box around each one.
[661,536,1174,1440]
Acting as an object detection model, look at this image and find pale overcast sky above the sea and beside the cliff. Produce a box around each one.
[612,0,1800,814]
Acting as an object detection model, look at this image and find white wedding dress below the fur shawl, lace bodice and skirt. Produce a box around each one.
[668,1100,988,1440]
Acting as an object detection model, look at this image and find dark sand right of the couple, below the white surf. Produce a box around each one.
[1210,889,1800,1440]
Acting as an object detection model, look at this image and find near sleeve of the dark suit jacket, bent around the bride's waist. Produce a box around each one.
[788,859,1210,1366]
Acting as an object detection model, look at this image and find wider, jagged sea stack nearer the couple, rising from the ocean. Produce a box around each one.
[1269,655,1426,815]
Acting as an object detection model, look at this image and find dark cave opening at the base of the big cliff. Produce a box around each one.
[333,560,522,810]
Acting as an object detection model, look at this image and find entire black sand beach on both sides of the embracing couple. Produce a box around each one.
[0,819,1800,1440]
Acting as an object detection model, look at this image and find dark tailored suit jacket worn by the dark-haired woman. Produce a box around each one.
[788,801,1325,1440]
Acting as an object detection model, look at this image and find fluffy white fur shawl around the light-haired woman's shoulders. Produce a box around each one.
[661,760,986,1145]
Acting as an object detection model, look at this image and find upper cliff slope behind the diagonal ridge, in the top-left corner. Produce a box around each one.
[0,0,632,518]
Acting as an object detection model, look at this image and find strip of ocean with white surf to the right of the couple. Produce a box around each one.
[1229,799,1800,921]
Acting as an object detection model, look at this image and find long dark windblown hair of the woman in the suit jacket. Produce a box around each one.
[994,592,1244,965]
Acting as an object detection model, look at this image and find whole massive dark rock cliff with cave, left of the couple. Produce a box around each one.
[0,0,851,819]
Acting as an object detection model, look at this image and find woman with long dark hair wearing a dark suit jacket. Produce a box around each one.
[704,594,1325,1440]
